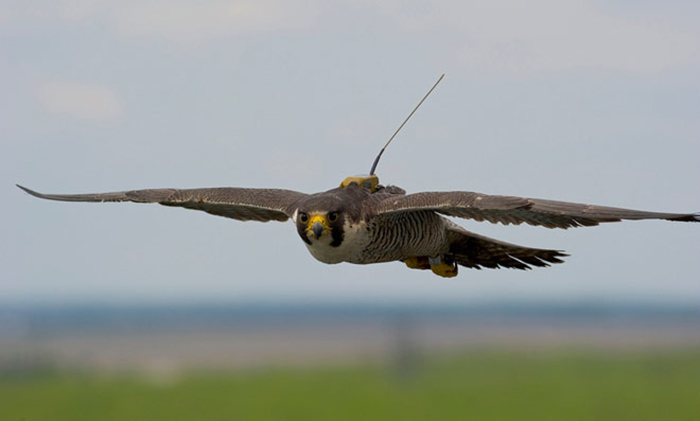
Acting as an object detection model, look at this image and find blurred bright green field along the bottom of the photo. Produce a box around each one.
[0,351,700,420]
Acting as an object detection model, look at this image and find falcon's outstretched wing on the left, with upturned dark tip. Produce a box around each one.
[17,185,307,222]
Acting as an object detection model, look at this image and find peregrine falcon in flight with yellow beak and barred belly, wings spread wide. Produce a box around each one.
[18,176,700,277]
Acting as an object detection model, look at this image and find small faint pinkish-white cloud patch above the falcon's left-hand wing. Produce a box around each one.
[37,82,121,123]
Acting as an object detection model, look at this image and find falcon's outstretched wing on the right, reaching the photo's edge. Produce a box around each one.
[377,192,700,229]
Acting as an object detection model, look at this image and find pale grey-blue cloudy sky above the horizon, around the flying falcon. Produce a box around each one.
[0,0,700,304]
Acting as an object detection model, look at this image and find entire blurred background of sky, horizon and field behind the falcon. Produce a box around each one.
[0,0,700,420]
